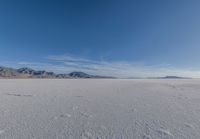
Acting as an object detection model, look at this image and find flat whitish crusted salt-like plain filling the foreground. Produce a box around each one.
[0,79,200,139]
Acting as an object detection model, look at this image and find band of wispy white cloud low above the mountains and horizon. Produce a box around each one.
[7,55,200,77]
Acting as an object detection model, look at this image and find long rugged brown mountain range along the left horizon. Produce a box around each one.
[0,67,112,79]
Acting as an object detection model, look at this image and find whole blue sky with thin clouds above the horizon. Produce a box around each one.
[0,0,200,77]
